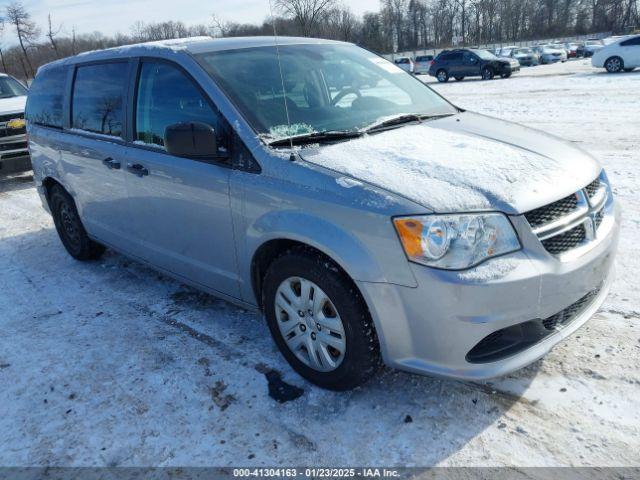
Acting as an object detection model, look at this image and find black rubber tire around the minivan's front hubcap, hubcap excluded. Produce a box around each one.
[262,247,381,391]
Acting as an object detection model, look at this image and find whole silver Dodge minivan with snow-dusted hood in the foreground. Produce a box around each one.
[27,38,619,389]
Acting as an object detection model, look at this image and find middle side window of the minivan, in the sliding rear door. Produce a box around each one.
[71,62,128,137]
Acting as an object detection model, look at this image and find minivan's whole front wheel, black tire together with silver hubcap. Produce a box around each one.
[263,247,380,390]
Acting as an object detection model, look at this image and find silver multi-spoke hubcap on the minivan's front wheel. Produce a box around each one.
[275,277,347,372]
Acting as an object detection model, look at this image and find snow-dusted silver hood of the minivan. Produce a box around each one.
[300,112,601,214]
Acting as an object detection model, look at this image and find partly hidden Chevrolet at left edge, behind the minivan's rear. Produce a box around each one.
[0,73,31,175]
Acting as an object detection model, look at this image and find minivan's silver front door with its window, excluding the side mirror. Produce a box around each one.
[126,60,240,298]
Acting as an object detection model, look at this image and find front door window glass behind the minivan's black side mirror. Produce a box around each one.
[134,62,227,147]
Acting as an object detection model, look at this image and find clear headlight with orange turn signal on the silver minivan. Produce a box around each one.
[393,213,521,270]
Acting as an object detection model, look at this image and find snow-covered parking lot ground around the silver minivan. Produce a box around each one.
[0,61,640,466]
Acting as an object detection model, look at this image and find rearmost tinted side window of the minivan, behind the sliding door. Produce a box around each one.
[26,67,67,128]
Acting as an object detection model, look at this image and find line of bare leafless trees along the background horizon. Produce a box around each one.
[0,0,640,80]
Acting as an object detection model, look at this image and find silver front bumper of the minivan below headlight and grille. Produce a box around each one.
[359,197,620,379]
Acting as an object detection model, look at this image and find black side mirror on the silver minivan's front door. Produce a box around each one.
[164,122,218,158]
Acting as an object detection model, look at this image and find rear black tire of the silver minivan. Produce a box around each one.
[49,185,105,261]
